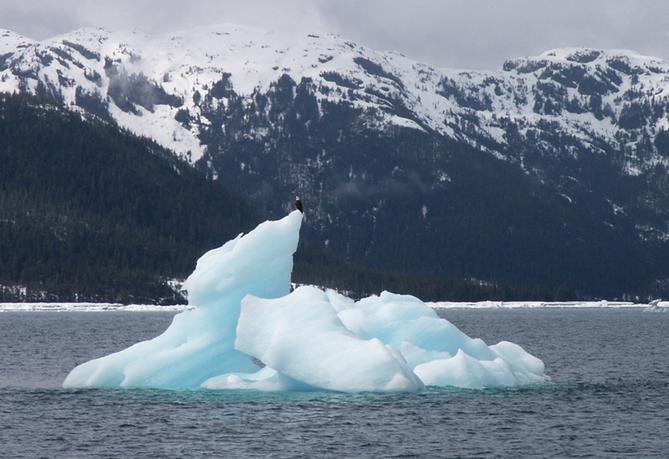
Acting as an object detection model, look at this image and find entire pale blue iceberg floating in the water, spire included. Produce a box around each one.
[63,211,549,392]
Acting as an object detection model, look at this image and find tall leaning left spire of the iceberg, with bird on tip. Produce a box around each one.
[63,212,302,389]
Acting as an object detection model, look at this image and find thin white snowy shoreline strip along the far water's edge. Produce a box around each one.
[0,301,669,312]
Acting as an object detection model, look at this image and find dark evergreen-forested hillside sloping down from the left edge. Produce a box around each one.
[0,91,259,302]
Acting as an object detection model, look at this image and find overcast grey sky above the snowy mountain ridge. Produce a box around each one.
[0,0,669,69]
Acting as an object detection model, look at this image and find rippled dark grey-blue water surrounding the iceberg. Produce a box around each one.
[0,310,669,458]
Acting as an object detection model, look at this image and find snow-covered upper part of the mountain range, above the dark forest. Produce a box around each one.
[0,25,669,169]
